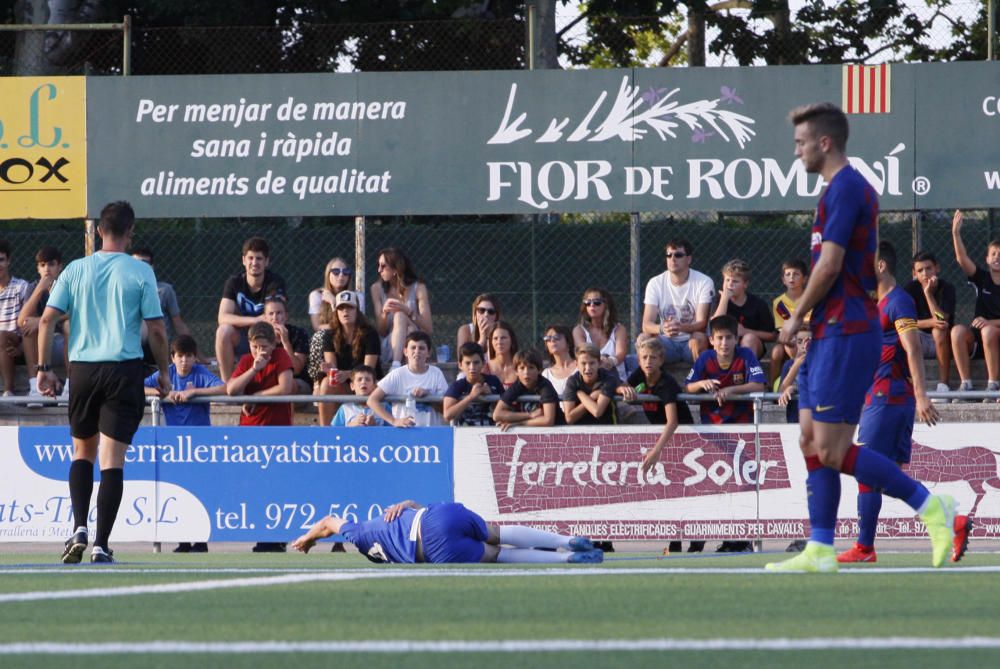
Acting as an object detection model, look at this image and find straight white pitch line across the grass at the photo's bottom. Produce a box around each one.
[0,637,1000,656]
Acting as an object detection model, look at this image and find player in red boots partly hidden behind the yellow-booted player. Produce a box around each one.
[837,242,971,562]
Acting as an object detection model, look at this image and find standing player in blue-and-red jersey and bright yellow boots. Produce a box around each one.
[767,103,968,572]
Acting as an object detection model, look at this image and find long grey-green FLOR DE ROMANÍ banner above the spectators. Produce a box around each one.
[0,62,1000,218]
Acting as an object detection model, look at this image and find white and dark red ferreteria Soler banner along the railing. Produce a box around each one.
[455,424,1000,540]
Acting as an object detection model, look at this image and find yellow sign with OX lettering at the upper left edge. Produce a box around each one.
[0,77,87,219]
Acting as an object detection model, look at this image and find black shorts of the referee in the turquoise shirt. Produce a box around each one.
[69,359,146,444]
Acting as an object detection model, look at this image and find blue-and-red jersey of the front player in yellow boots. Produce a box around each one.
[810,165,878,339]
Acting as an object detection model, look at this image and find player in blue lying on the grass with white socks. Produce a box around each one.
[292,500,604,564]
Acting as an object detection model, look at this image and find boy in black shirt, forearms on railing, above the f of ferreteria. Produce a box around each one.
[493,349,563,432]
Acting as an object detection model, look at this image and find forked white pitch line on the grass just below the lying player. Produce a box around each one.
[0,566,1000,603]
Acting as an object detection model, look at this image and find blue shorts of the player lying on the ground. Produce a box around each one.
[420,502,489,564]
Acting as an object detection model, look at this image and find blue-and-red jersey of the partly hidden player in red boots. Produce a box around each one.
[865,286,917,404]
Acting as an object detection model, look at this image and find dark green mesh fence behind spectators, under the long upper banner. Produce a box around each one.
[0,211,1000,358]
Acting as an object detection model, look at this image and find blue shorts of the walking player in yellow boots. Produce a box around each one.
[798,330,882,425]
